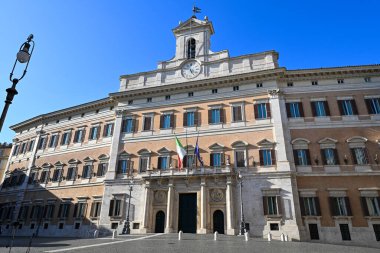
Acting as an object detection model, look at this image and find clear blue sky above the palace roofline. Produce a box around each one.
[0,0,380,142]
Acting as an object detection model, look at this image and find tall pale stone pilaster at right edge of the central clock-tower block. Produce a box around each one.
[268,89,293,171]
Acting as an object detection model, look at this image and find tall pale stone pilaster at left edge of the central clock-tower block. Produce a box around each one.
[106,110,124,180]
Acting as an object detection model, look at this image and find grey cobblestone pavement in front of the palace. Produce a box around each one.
[0,234,380,253]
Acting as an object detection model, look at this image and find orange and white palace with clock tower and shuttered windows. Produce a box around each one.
[0,16,380,243]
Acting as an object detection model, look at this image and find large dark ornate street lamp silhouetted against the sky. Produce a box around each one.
[0,34,34,132]
